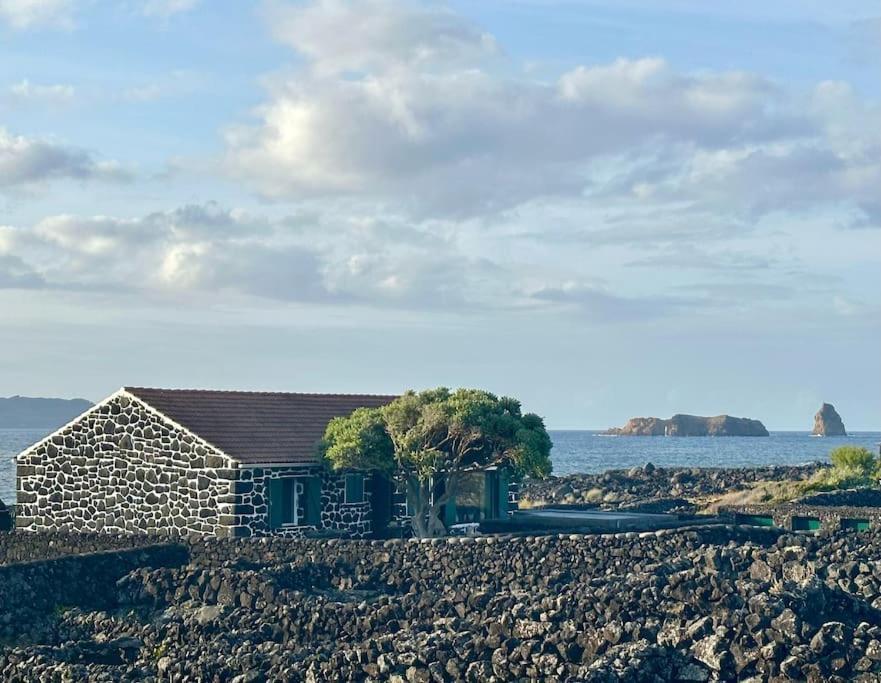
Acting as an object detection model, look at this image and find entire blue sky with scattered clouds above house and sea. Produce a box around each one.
[0,0,881,430]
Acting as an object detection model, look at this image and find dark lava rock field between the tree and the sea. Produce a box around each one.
[520,463,826,512]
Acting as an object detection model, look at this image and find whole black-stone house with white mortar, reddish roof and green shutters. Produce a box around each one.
[15,387,515,537]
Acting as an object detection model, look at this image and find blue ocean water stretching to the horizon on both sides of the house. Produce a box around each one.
[0,429,881,502]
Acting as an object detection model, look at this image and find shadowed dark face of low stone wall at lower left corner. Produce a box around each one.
[0,544,187,638]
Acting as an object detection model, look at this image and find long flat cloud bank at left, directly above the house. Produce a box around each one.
[0,203,510,311]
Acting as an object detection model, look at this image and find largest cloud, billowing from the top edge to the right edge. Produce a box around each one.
[225,0,879,220]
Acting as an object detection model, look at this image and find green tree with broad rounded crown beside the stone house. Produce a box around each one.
[321,387,551,538]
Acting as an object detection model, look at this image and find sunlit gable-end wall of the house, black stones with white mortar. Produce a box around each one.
[16,394,238,534]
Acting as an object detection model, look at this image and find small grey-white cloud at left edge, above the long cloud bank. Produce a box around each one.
[0,127,130,190]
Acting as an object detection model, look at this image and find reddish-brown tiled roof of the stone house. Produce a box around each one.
[125,387,397,464]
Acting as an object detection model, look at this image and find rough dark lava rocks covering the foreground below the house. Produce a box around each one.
[0,527,881,683]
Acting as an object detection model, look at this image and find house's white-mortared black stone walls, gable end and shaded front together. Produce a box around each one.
[16,394,370,536]
